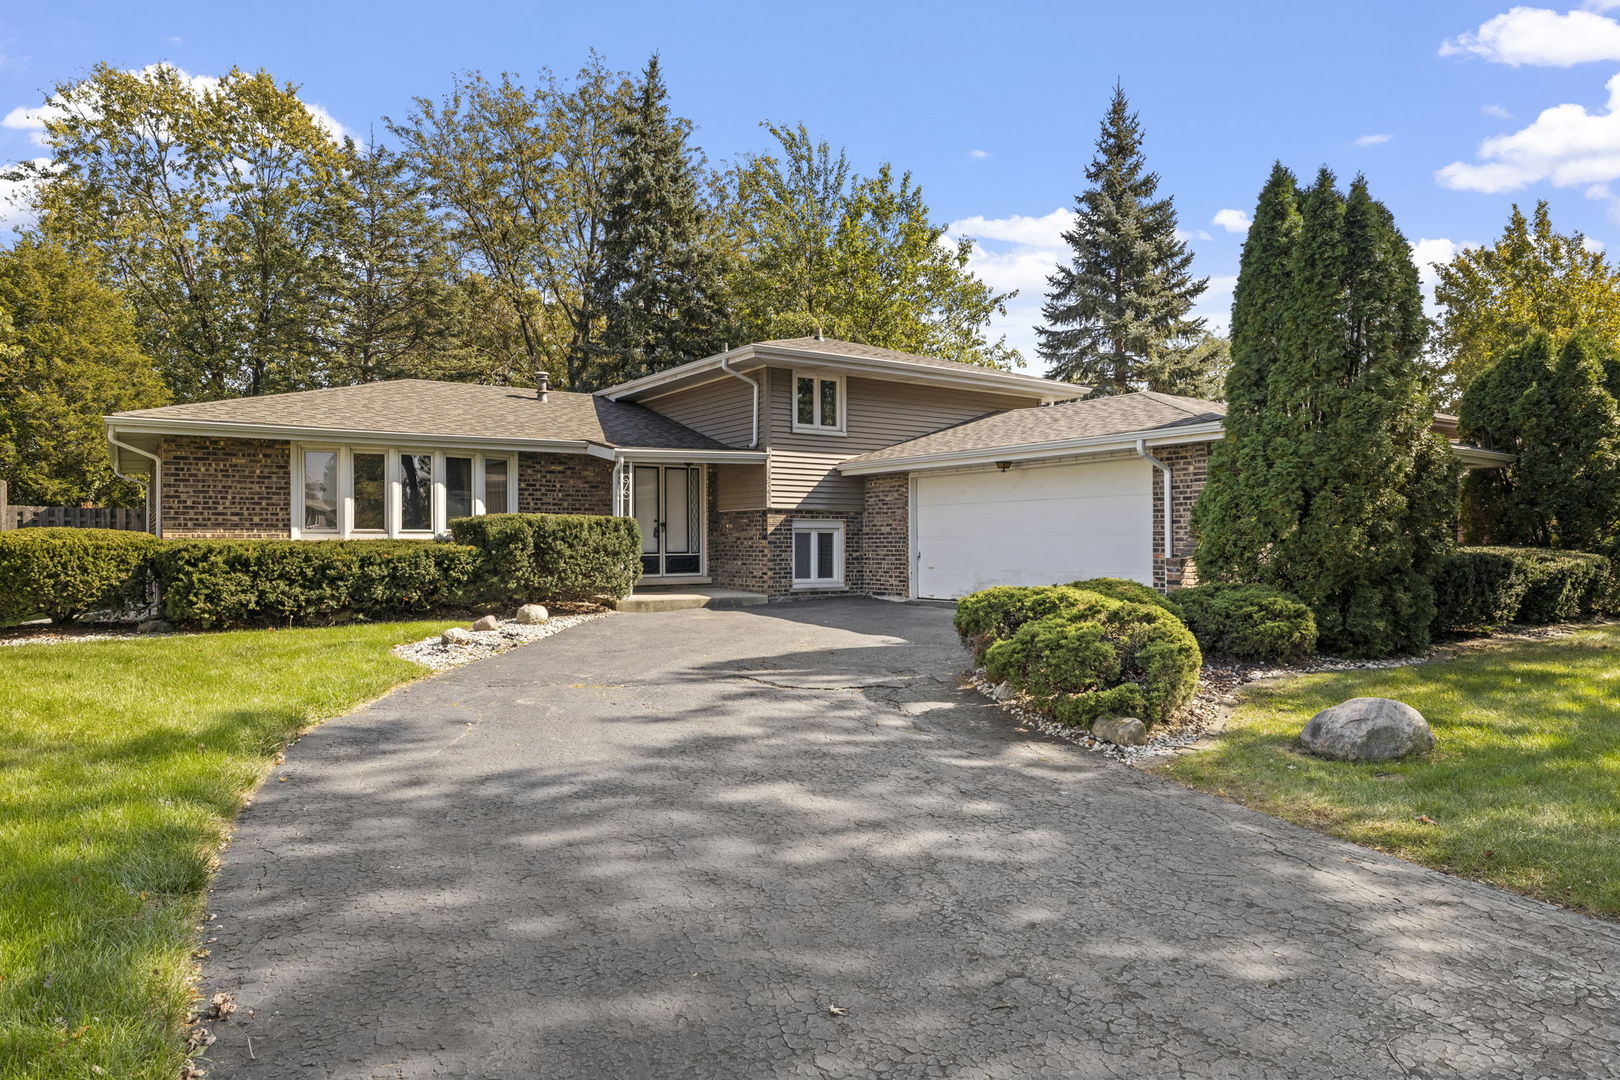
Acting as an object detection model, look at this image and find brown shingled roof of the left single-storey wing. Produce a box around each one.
[107,379,731,450]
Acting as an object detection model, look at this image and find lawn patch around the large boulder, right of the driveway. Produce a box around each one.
[1163,627,1620,918]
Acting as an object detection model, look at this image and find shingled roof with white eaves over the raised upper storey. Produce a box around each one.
[596,337,1089,402]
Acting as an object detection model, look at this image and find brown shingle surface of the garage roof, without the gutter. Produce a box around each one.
[844,390,1226,465]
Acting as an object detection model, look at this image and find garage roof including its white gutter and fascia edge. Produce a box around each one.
[839,390,1226,473]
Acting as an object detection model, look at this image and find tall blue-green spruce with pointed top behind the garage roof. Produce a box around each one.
[1035,86,1209,395]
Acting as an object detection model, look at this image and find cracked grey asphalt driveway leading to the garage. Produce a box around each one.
[206,601,1620,1080]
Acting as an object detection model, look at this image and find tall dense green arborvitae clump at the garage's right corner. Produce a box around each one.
[1194,168,1456,656]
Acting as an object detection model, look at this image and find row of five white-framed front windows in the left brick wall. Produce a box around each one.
[292,445,517,539]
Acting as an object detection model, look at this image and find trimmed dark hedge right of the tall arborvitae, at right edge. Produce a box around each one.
[1434,547,1615,630]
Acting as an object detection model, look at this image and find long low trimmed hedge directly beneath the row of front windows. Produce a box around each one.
[152,539,483,630]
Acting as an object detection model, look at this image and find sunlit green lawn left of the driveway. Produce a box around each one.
[0,622,446,1080]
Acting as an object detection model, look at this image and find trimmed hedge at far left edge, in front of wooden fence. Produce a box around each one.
[0,528,160,622]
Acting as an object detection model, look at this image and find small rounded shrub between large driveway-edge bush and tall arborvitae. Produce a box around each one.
[1170,585,1317,664]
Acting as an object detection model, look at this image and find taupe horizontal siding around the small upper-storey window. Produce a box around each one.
[767,368,1037,510]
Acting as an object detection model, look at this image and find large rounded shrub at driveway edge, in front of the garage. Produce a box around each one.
[985,589,1204,725]
